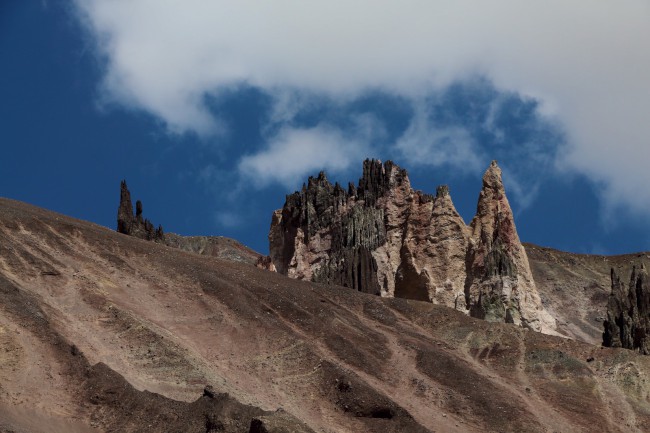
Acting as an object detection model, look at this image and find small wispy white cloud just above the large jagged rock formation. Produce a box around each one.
[238,125,368,188]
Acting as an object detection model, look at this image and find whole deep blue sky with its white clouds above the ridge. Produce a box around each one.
[0,0,650,253]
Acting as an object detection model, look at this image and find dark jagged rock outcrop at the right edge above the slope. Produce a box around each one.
[603,265,650,355]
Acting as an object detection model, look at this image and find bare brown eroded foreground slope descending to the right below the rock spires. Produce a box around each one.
[0,199,650,432]
